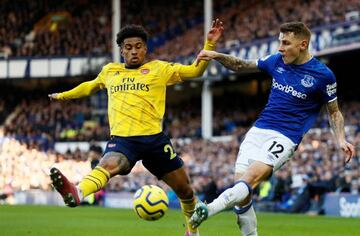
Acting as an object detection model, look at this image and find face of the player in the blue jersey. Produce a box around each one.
[279,32,308,64]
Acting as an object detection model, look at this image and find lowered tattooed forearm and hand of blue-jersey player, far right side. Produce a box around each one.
[327,100,355,163]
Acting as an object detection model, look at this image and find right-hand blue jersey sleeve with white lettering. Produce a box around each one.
[320,70,337,103]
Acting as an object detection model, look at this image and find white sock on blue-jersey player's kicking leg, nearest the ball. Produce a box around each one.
[207,182,250,216]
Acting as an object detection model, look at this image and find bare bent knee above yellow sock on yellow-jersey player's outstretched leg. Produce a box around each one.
[99,152,131,176]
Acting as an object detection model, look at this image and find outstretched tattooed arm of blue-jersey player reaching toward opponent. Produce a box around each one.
[196,50,259,72]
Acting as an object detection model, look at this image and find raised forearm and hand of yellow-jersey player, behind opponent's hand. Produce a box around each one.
[179,19,224,79]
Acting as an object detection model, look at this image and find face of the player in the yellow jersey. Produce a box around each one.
[121,37,147,67]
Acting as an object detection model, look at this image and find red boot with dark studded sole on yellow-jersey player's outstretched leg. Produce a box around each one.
[50,168,80,207]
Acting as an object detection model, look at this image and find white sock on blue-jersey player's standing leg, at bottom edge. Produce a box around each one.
[237,205,258,236]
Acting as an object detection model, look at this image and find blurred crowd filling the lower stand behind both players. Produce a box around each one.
[0,90,360,213]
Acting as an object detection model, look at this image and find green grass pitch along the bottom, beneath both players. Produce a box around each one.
[0,206,360,236]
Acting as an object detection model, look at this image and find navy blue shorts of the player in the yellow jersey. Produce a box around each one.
[104,132,184,179]
